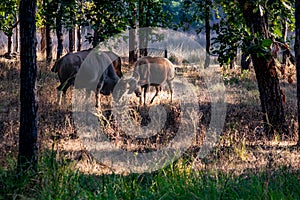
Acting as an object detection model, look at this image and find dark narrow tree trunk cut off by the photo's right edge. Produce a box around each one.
[294,1,300,145]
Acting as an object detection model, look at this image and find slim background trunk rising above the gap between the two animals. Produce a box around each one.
[128,2,138,66]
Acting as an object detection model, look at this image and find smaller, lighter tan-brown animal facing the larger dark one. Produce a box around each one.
[128,56,175,105]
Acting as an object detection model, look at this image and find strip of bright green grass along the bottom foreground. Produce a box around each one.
[0,153,300,200]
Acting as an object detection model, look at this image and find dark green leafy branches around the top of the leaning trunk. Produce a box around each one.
[212,0,294,65]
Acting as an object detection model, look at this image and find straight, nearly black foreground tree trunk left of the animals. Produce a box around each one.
[18,0,38,172]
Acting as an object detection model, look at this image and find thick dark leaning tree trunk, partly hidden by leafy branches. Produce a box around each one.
[239,0,289,139]
